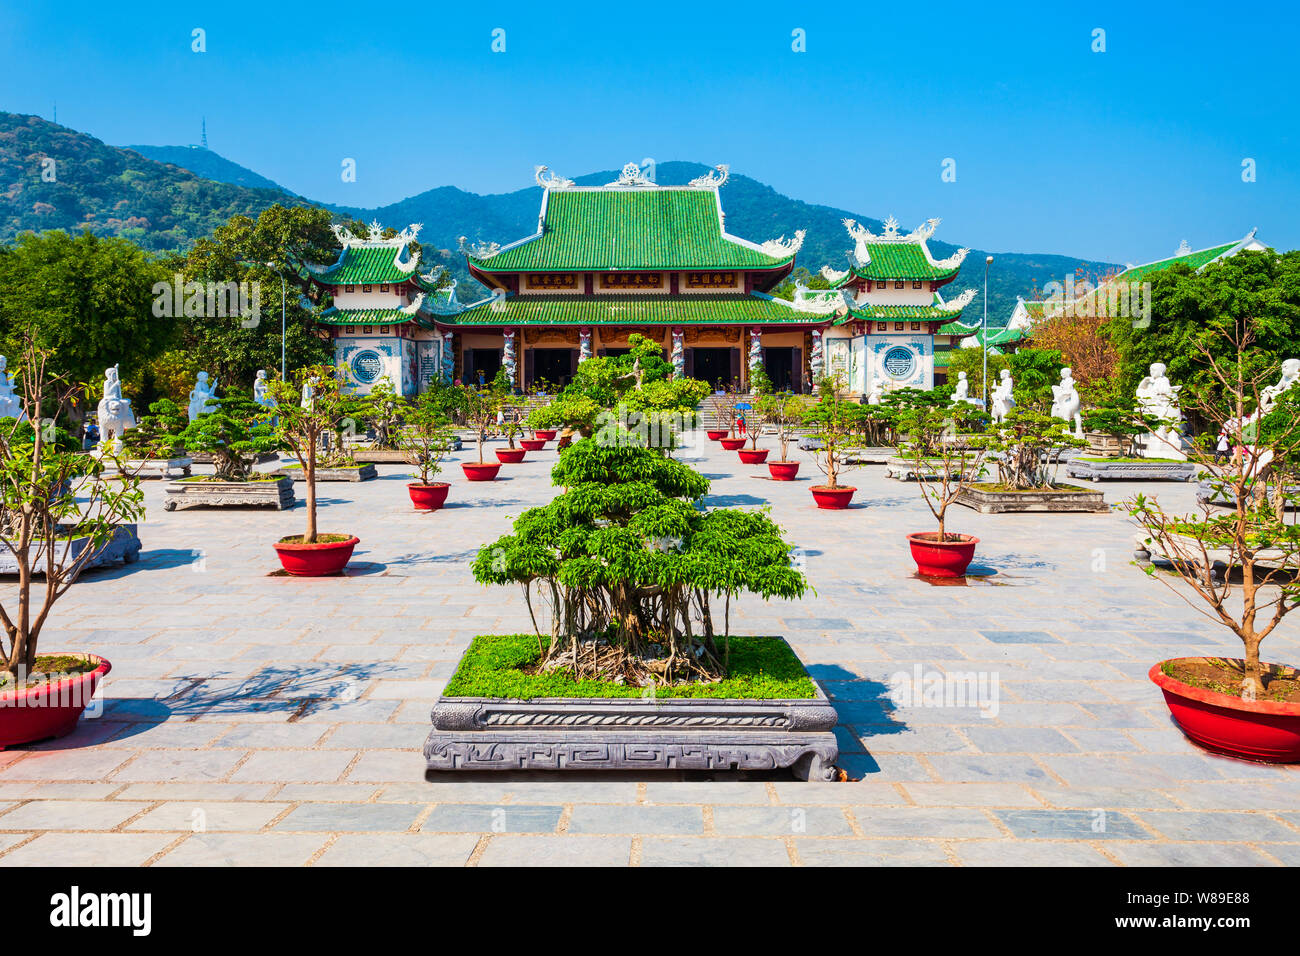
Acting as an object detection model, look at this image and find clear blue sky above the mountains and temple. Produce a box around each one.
[0,0,1300,263]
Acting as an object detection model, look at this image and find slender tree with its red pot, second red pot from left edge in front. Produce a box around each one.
[268,365,360,578]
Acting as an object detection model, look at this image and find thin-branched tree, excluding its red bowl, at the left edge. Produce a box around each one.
[0,338,144,687]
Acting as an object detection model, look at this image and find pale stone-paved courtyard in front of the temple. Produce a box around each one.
[0,442,1300,866]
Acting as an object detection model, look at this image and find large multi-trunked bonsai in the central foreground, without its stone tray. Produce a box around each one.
[473,441,807,684]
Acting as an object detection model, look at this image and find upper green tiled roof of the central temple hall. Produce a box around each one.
[468,189,794,272]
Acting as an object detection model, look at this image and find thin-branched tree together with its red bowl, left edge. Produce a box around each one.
[0,339,144,747]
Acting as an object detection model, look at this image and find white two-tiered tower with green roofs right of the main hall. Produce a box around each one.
[822,216,975,395]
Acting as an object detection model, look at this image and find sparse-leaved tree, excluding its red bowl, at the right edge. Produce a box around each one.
[1126,330,1300,700]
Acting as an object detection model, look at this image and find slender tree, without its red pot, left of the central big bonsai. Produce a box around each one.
[267,365,350,545]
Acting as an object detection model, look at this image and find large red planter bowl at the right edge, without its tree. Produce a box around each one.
[1147,658,1300,763]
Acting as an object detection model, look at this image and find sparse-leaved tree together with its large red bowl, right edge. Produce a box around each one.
[1126,329,1300,762]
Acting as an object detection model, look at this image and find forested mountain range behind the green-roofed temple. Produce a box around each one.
[0,112,1113,324]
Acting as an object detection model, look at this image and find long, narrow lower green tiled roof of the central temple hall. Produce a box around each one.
[434,293,829,325]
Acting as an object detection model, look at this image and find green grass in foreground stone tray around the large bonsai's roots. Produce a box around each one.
[443,635,816,700]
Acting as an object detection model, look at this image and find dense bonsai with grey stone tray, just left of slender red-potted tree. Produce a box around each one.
[163,389,294,511]
